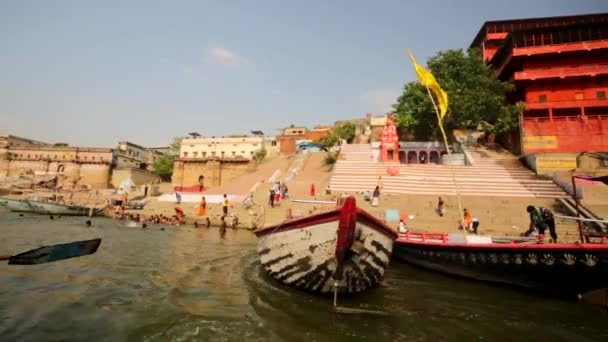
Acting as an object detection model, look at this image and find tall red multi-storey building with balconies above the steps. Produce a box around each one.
[471,13,608,154]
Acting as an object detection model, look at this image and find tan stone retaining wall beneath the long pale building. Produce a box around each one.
[172,159,257,187]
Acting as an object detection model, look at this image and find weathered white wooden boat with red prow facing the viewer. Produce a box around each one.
[254,197,397,293]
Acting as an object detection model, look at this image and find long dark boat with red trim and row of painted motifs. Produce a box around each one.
[394,233,608,295]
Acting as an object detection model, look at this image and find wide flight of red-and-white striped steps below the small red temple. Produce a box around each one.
[330,144,567,198]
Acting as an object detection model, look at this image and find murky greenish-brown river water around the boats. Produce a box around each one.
[0,212,608,341]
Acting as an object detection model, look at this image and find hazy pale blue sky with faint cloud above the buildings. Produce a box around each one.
[0,0,608,147]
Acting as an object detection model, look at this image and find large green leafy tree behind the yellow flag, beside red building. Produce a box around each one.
[394,49,521,136]
